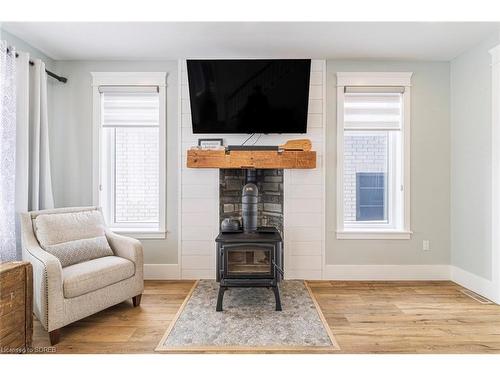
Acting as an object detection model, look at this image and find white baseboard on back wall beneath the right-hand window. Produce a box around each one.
[323,264,450,281]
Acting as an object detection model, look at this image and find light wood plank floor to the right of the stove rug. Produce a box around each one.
[310,281,500,353]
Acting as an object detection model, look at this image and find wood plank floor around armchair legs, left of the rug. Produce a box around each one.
[33,280,193,353]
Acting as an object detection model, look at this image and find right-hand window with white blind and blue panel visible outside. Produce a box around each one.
[337,73,410,238]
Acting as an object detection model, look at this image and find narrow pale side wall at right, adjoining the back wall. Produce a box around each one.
[450,35,500,284]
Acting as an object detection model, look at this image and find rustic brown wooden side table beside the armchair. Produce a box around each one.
[0,262,33,354]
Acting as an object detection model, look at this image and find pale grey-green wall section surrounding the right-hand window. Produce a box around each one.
[326,60,450,268]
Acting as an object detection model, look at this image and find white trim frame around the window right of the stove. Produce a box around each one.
[336,72,413,240]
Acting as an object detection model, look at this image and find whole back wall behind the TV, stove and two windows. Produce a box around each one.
[45,61,450,278]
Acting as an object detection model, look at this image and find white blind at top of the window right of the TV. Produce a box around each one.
[344,87,404,130]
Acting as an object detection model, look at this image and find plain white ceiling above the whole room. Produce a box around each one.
[2,22,500,61]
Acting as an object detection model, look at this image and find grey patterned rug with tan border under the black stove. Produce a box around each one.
[156,280,340,353]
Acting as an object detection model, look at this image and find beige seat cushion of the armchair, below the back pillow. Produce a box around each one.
[62,256,135,298]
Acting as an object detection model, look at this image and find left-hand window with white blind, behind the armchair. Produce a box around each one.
[94,86,164,238]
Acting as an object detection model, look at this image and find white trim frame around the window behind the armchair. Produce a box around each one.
[91,72,167,239]
